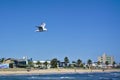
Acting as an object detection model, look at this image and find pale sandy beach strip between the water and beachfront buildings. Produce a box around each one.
[0,69,120,76]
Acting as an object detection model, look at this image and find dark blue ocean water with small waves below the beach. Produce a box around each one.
[0,72,120,80]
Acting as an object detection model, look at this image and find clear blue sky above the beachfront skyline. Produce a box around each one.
[0,0,120,62]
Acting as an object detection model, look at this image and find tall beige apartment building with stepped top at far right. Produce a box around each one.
[98,53,114,64]
